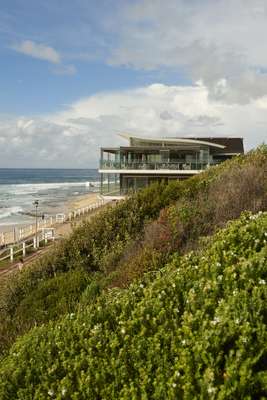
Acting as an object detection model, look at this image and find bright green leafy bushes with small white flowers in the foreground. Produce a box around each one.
[0,213,267,400]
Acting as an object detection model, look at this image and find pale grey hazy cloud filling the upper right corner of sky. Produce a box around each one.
[109,0,267,104]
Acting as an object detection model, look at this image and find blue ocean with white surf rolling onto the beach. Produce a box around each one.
[0,168,100,229]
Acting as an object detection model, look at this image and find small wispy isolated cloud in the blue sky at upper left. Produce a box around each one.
[12,40,61,64]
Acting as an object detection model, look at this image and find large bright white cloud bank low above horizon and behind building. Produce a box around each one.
[0,83,267,168]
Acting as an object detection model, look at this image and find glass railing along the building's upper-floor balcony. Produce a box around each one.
[100,160,215,171]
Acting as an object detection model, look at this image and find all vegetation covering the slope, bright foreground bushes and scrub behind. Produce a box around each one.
[0,146,267,399]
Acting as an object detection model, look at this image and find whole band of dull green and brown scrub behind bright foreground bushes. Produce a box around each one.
[0,146,267,352]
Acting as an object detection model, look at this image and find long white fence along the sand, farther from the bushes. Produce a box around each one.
[0,199,110,248]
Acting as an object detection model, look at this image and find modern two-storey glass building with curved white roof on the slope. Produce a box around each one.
[99,134,244,196]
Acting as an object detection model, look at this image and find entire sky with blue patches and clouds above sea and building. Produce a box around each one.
[0,0,267,168]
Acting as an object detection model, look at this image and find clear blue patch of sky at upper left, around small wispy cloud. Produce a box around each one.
[0,0,191,115]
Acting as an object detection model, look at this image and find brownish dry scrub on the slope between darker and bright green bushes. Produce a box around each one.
[111,146,267,286]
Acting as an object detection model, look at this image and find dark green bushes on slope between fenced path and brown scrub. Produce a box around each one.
[0,182,183,353]
